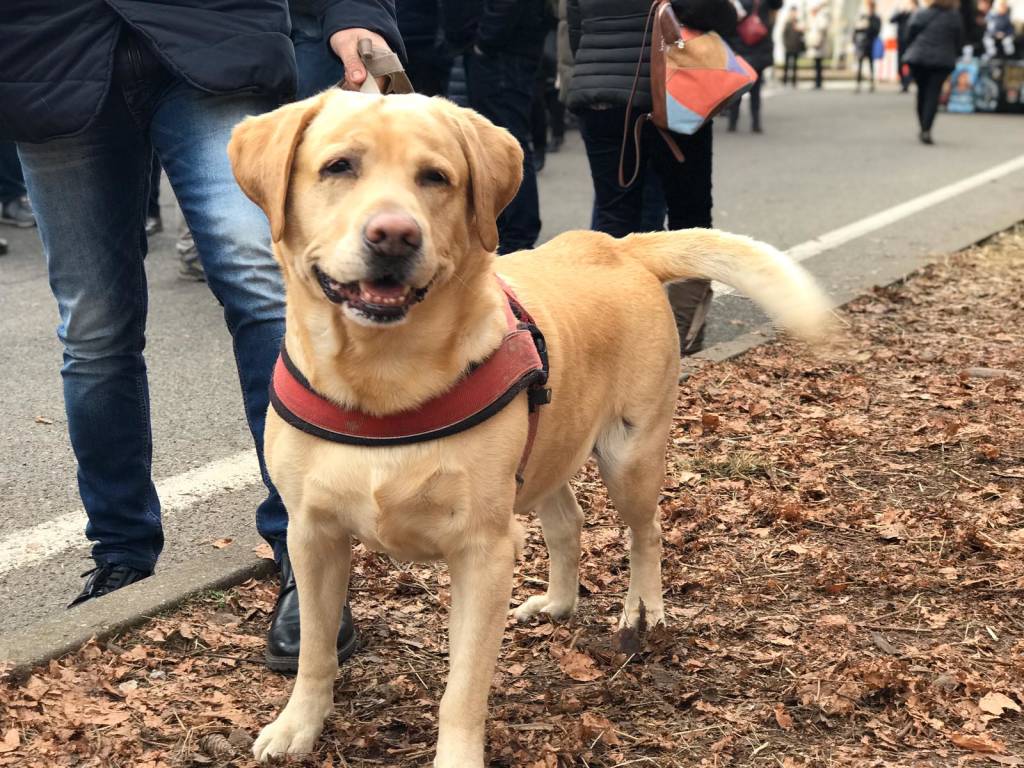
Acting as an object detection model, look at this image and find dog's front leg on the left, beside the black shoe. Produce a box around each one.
[253,514,352,761]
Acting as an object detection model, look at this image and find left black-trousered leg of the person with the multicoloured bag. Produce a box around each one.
[579,108,643,238]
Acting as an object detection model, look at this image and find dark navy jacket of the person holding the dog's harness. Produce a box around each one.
[0,0,401,141]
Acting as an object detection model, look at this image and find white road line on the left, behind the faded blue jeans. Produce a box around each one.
[0,449,260,575]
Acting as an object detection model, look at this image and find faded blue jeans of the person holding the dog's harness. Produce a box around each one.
[18,36,288,570]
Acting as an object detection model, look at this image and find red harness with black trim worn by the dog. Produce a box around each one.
[270,278,551,483]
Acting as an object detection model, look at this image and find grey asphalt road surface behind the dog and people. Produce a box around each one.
[0,82,1024,634]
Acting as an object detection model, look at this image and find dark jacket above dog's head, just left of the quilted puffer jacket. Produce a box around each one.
[444,0,550,59]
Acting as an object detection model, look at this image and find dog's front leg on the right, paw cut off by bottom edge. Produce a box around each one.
[434,536,515,768]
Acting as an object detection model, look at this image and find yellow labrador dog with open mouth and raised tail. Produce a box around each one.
[228,90,827,768]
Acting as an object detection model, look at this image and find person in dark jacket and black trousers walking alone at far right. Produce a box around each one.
[905,0,965,144]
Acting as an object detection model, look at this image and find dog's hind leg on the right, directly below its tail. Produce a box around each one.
[596,411,675,628]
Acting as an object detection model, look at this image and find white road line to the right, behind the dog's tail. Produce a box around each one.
[714,155,1024,297]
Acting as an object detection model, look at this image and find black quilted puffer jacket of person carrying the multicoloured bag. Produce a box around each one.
[567,0,736,111]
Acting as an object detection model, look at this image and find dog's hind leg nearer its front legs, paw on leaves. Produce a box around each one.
[512,483,583,622]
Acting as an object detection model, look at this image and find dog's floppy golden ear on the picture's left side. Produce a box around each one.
[227,93,326,242]
